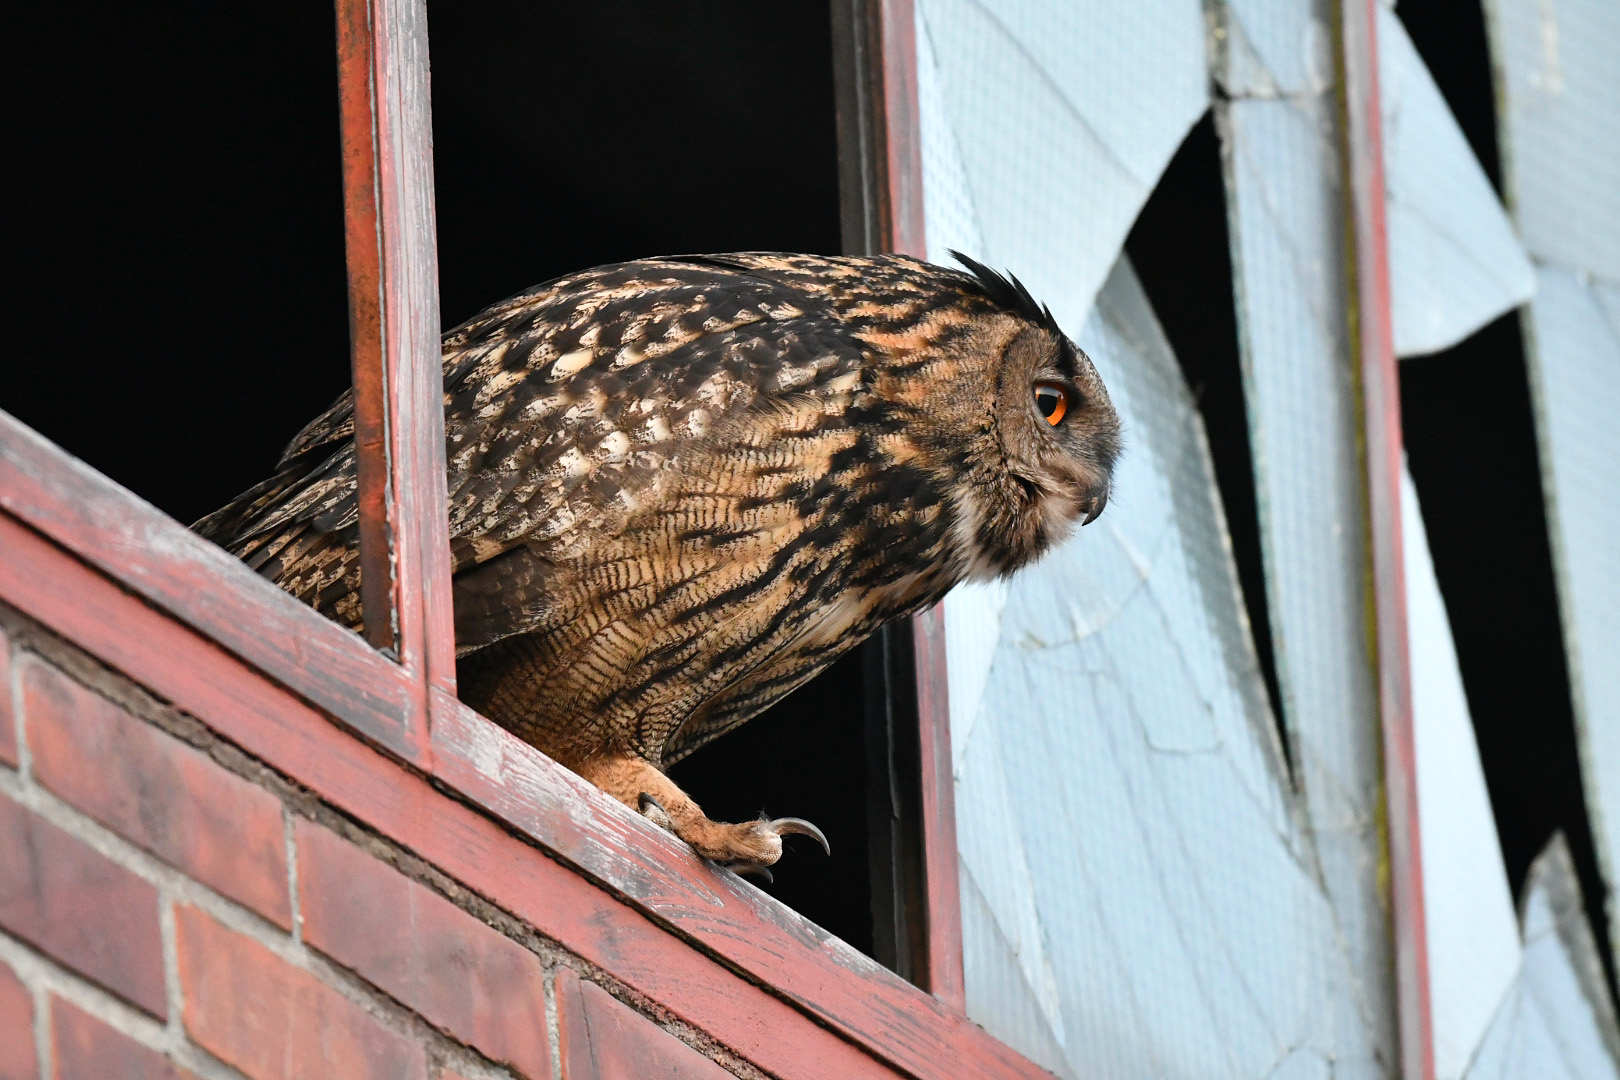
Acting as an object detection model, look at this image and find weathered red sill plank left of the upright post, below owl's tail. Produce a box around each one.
[0,411,426,763]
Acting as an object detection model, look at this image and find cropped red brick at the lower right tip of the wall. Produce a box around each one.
[557,968,735,1080]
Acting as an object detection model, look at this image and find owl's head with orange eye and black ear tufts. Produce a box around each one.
[900,253,1119,580]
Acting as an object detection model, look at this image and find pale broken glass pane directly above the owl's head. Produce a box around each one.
[917,0,1209,311]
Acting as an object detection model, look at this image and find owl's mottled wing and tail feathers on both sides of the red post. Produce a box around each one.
[196,261,862,653]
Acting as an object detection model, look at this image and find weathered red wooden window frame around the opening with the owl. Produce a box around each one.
[0,0,1010,1080]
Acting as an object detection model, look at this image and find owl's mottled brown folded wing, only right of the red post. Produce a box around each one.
[446,262,862,653]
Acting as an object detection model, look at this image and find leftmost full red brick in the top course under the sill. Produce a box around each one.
[21,661,292,928]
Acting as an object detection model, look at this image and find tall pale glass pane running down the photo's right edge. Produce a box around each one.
[1486,0,1620,971]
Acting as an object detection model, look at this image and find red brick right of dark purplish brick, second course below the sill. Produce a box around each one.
[175,905,428,1080]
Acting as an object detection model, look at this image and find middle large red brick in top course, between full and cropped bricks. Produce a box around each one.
[296,821,551,1078]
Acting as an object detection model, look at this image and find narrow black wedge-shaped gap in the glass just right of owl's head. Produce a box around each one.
[1124,113,1288,753]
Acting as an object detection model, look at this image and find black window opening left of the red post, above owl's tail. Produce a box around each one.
[0,0,350,523]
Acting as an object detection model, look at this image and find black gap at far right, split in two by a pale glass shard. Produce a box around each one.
[1400,0,1615,993]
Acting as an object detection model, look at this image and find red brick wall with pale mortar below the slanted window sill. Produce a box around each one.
[0,607,761,1080]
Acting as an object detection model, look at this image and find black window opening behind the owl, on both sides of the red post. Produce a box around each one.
[12,0,913,952]
